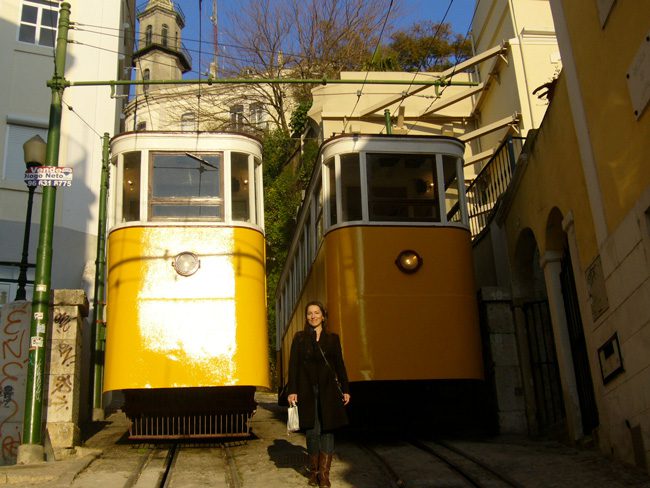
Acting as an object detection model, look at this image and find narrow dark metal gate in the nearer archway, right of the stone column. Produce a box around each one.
[560,251,598,435]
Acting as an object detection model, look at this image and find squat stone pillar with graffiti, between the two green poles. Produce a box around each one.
[46,290,88,457]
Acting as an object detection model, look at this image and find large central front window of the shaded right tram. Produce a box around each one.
[366,154,440,222]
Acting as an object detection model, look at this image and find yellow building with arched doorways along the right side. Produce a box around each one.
[475,0,650,470]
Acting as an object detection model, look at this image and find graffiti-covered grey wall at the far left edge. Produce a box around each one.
[0,301,31,465]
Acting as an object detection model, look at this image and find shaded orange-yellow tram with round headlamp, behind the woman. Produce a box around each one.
[276,134,484,428]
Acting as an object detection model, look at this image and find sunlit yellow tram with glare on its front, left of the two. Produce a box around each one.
[104,131,269,438]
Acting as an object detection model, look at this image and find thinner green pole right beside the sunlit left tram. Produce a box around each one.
[93,132,110,421]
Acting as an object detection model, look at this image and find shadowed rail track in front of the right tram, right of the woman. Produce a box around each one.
[362,440,523,488]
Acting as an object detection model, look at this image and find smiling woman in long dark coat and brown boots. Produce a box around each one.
[287,301,350,487]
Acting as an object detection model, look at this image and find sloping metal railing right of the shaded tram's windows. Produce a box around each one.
[467,137,526,238]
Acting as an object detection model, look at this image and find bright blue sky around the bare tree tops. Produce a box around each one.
[168,0,476,77]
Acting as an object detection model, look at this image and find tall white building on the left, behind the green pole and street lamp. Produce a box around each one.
[0,0,136,306]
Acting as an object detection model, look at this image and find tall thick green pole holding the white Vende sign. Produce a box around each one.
[18,2,70,464]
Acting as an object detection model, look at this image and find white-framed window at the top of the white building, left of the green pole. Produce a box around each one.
[18,0,60,47]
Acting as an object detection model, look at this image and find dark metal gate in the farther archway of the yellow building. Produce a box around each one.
[522,300,565,434]
